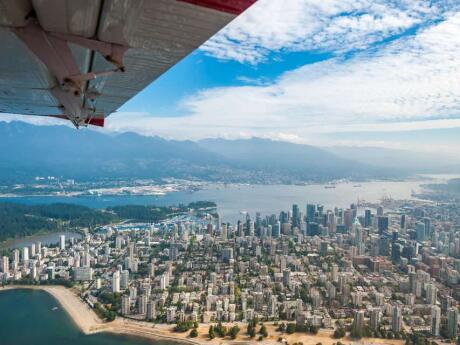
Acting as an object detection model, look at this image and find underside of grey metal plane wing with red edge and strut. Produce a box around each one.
[0,0,256,127]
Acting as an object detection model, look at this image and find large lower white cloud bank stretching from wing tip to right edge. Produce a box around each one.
[100,13,460,144]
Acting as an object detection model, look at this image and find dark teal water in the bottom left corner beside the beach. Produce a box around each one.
[0,289,179,345]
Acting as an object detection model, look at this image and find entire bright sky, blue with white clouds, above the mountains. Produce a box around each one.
[2,0,460,154]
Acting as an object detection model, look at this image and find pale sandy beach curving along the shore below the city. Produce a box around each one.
[0,286,404,345]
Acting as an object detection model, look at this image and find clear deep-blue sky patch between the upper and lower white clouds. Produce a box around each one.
[120,50,331,117]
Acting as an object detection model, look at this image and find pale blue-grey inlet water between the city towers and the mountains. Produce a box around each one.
[0,176,446,223]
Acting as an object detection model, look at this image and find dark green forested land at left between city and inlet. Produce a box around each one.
[0,201,216,242]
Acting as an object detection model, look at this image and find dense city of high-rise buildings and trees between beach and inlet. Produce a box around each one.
[0,195,460,344]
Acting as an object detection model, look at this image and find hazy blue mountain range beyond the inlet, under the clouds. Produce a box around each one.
[0,122,454,183]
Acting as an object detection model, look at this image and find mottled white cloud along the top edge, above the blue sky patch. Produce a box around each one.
[201,0,459,64]
